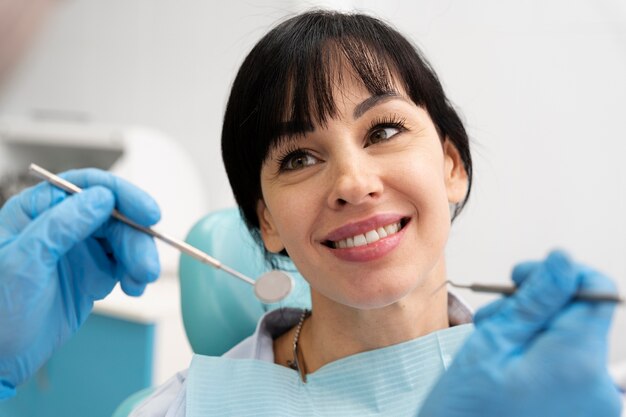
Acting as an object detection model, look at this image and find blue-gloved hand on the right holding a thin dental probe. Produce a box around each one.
[419,252,622,417]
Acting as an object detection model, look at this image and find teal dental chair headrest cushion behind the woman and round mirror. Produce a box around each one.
[179,208,311,356]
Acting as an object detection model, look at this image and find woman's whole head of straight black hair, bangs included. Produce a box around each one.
[222,13,472,234]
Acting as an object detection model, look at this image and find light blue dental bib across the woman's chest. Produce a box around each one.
[186,324,474,417]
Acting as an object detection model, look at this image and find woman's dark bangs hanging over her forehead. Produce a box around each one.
[259,15,405,158]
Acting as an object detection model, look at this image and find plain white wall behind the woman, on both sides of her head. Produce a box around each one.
[0,0,626,360]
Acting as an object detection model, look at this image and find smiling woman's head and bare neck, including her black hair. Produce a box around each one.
[222,8,472,372]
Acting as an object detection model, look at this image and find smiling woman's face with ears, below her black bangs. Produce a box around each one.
[257,76,467,309]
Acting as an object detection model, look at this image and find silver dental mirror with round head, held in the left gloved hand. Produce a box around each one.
[28,164,294,304]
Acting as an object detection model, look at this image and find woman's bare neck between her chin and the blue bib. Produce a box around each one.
[299,262,449,373]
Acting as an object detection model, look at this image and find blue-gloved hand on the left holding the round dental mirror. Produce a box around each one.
[0,169,160,399]
